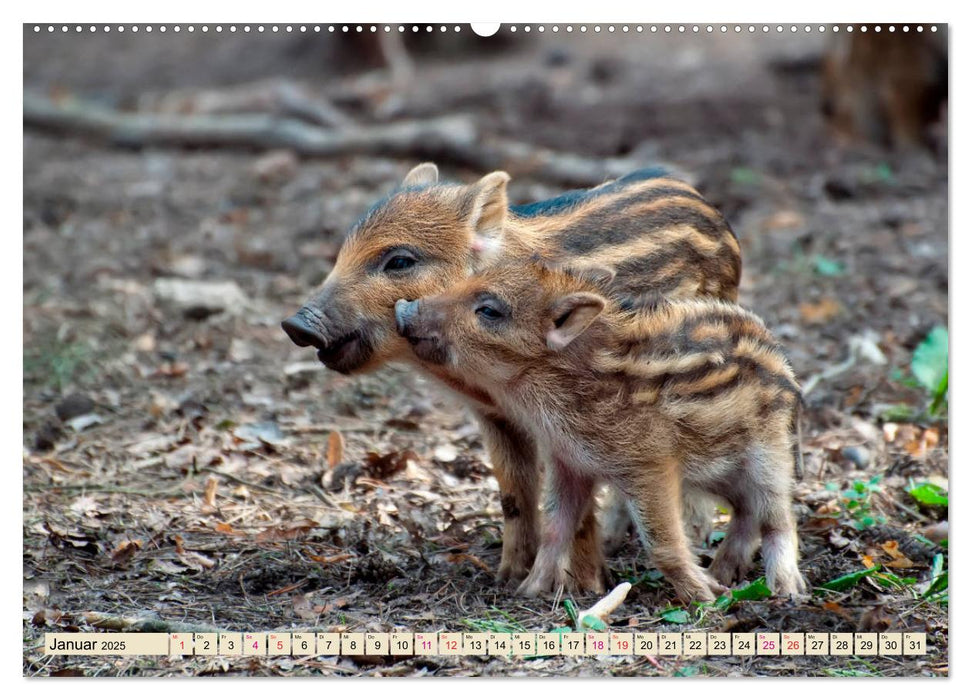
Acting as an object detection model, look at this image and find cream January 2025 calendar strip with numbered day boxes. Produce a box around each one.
[44,632,927,658]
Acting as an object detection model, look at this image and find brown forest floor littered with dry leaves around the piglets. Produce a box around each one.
[23,28,948,676]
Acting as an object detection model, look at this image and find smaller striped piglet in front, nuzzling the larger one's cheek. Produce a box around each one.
[395,261,806,601]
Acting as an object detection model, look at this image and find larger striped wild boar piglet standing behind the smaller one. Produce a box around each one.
[283,163,742,592]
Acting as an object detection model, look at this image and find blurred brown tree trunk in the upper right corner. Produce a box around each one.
[822,26,947,149]
